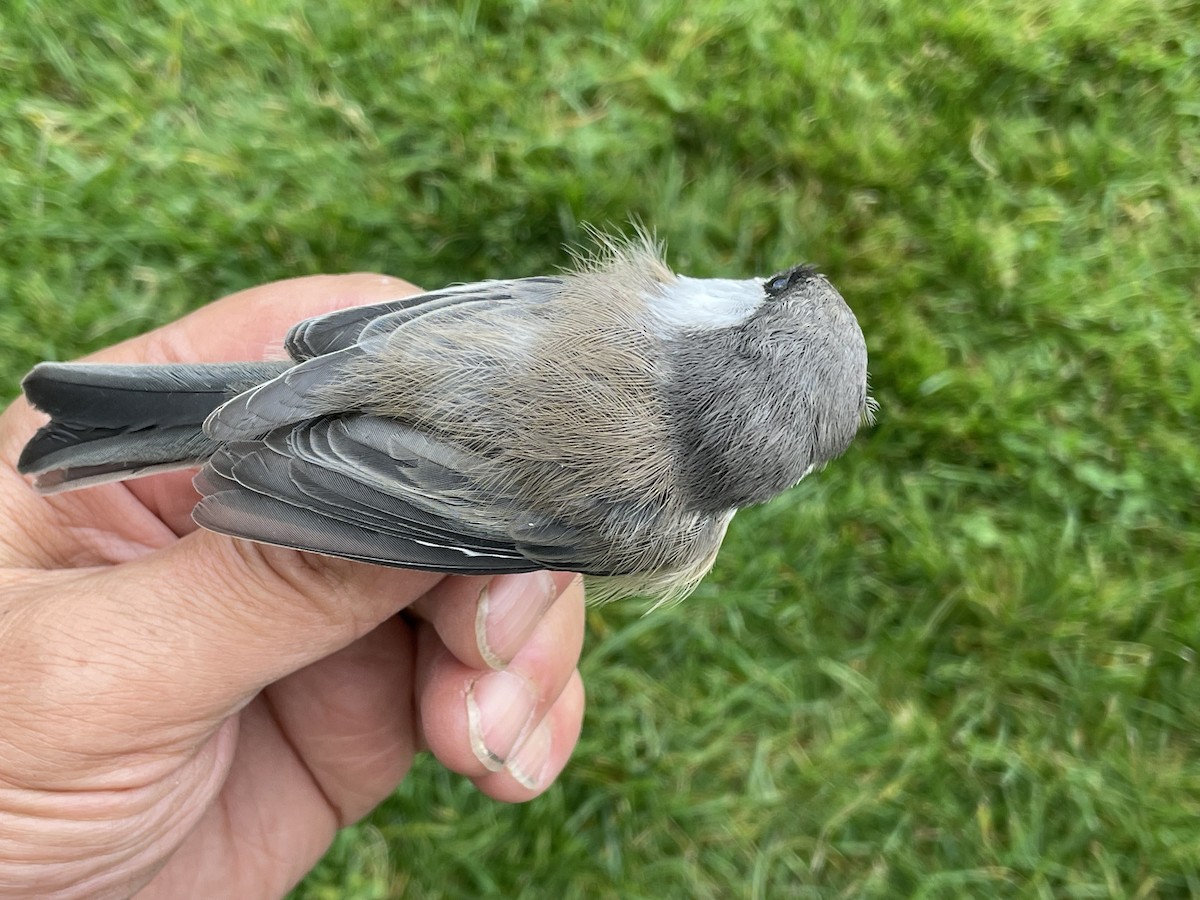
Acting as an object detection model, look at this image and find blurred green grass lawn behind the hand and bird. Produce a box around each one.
[0,0,1200,899]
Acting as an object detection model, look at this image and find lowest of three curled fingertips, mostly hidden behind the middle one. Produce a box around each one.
[473,670,584,803]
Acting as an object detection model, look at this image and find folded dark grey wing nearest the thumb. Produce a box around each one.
[193,415,544,574]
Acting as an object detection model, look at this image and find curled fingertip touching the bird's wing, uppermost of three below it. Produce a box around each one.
[412,571,575,668]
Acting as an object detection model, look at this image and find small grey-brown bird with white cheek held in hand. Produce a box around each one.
[18,235,875,601]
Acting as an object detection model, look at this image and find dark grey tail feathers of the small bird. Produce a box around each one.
[17,362,293,493]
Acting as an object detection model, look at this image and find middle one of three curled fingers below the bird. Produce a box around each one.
[416,581,583,778]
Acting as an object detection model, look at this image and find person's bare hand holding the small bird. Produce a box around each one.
[0,275,583,898]
